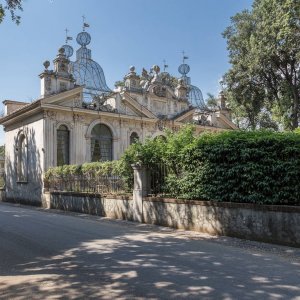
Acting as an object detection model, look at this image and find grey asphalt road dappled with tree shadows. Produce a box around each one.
[0,203,300,299]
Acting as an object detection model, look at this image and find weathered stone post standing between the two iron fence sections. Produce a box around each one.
[131,163,149,223]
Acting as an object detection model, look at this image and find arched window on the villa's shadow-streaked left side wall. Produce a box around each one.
[17,134,28,182]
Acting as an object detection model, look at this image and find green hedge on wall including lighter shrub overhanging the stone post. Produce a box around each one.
[122,126,300,205]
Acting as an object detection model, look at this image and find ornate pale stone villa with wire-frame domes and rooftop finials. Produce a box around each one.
[0,30,236,202]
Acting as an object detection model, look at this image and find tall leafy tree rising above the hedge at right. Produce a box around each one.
[223,0,300,129]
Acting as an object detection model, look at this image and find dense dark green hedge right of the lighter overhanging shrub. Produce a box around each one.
[177,131,300,205]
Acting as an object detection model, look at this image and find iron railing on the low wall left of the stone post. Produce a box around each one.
[44,175,128,195]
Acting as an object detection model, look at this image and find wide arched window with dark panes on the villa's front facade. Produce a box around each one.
[91,124,112,161]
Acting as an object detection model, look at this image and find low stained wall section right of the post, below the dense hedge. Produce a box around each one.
[143,198,300,247]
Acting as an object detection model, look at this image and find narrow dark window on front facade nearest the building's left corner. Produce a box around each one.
[57,125,70,166]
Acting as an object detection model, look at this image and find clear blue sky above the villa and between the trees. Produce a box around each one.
[0,0,253,144]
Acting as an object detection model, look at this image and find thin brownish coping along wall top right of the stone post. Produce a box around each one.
[143,197,300,213]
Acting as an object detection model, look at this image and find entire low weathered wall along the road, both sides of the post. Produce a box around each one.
[45,192,300,247]
